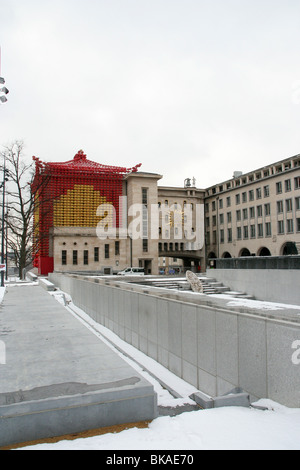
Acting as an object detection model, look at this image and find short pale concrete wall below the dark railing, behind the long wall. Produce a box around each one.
[207,269,300,305]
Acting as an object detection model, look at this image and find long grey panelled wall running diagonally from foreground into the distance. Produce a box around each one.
[50,274,300,407]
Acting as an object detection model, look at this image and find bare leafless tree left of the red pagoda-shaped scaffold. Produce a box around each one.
[1,140,34,279]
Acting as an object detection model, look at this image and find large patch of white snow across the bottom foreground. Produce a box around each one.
[22,400,300,452]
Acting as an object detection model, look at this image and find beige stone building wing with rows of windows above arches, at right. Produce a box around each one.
[205,155,300,259]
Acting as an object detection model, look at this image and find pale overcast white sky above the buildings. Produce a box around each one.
[0,0,300,188]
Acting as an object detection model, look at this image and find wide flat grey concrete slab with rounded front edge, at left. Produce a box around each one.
[0,286,157,446]
